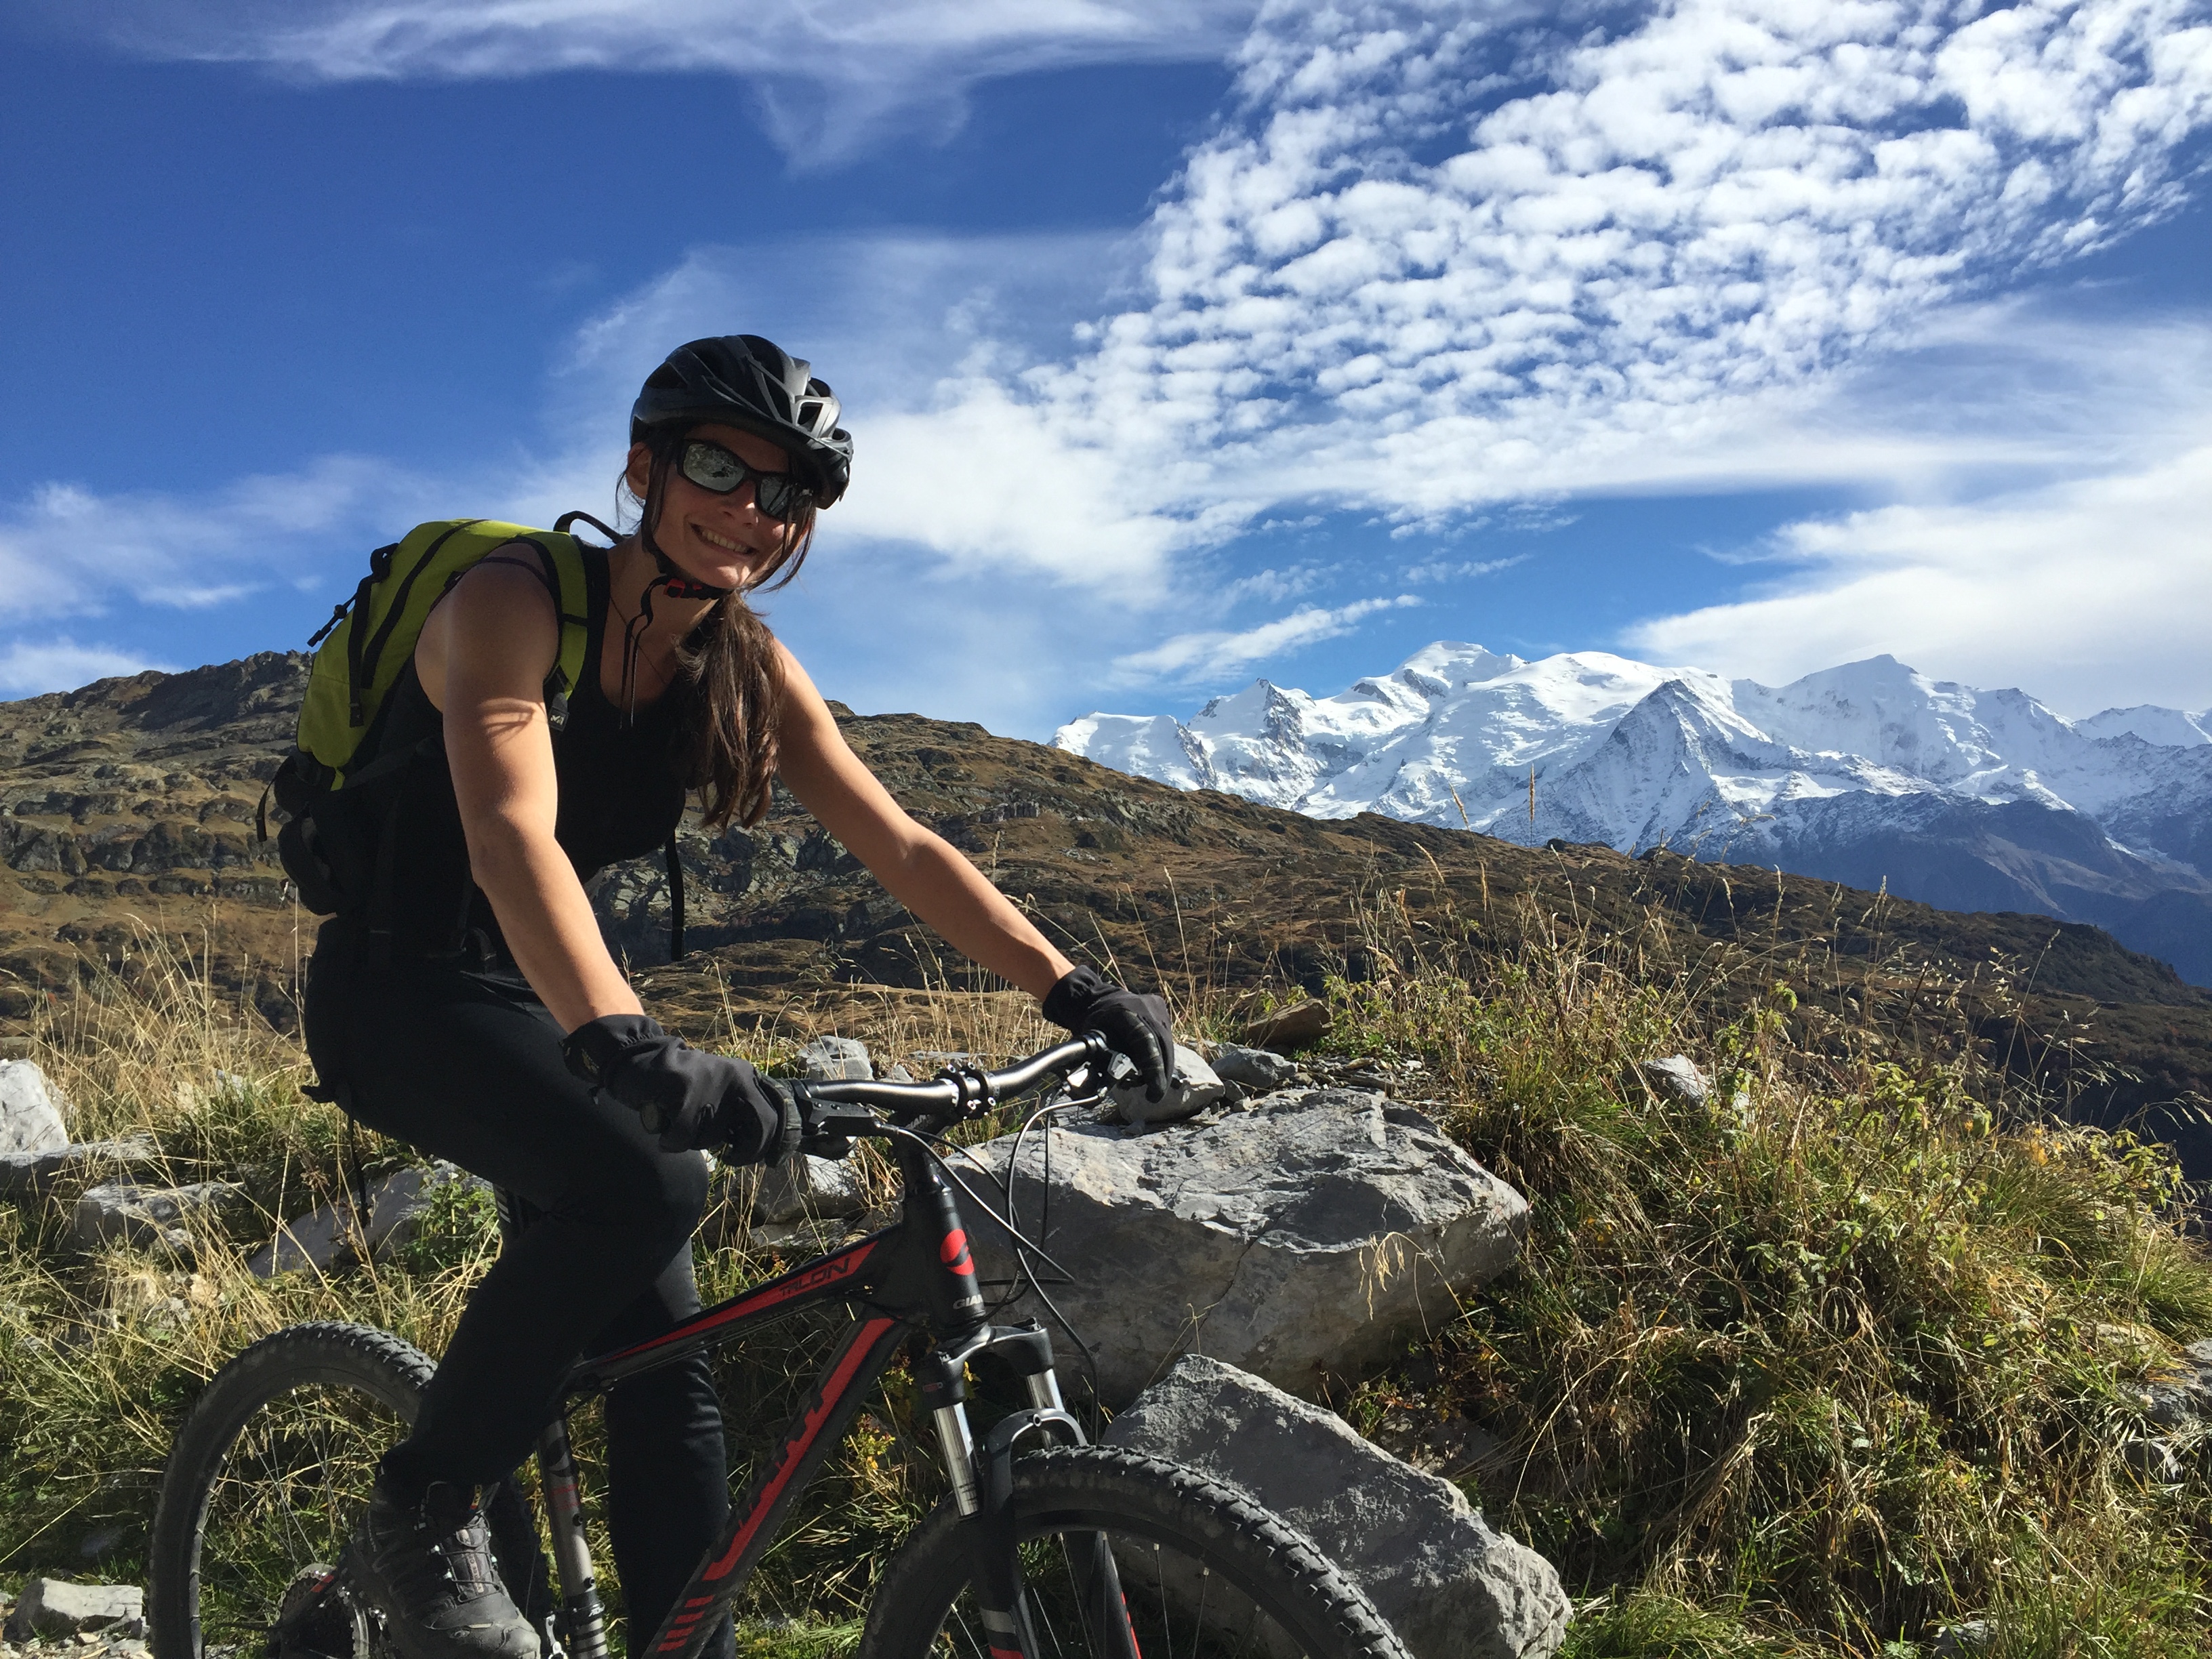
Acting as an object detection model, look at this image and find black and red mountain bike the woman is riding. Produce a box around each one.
[150,1036,1405,1659]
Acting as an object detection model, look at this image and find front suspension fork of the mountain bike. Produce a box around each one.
[916,1325,1143,1659]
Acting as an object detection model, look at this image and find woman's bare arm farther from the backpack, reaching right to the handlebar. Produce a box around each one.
[777,644,1073,1000]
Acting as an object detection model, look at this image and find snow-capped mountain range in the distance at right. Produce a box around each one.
[1053,642,2212,984]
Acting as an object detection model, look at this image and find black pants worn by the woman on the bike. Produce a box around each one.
[305,922,730,1652]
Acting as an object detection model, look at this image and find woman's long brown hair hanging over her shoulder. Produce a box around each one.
[617,422,816,830]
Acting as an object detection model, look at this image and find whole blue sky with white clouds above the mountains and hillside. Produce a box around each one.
[0,0,2212,737]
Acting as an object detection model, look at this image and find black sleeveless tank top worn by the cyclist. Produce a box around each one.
[378,546,686,956]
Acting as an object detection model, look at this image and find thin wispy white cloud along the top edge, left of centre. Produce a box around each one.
[70,0,1252,164]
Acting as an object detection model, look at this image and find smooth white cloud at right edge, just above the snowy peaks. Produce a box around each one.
[1628,436,2212,717]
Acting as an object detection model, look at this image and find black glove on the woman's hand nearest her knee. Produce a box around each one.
[560,1013,803,1164]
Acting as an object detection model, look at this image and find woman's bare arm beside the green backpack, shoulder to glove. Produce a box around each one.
[416,564,644,1031]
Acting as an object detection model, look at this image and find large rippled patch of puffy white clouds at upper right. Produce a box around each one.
[1000,0,2212,520]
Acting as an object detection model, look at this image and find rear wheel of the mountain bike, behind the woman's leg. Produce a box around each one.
[148,1323,551,1659]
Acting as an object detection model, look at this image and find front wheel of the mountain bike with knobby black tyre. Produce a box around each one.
[856,1447,1407,1659]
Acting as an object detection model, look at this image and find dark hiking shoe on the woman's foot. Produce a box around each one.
[345,1480,537,1659]
